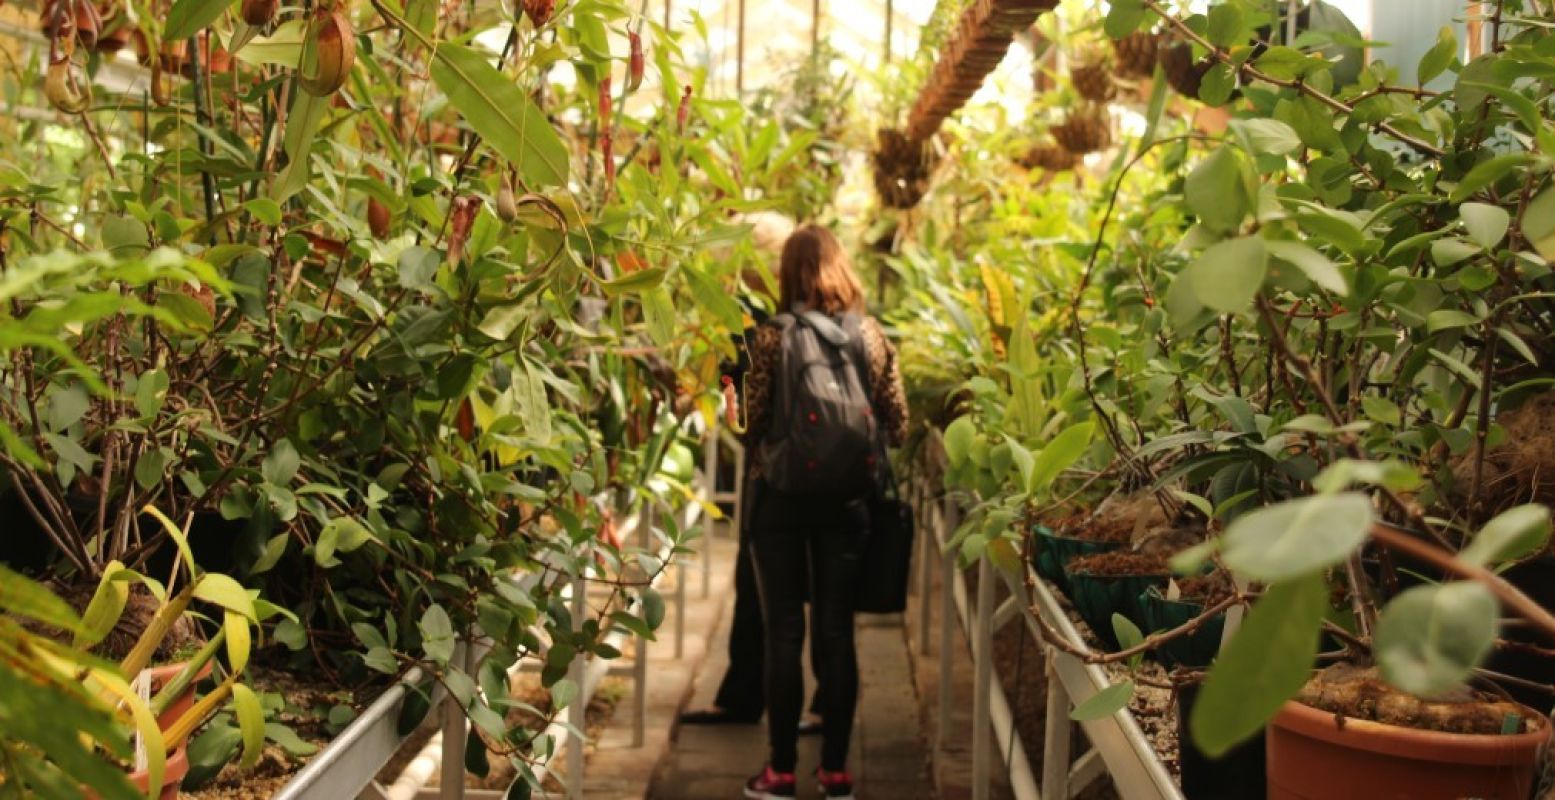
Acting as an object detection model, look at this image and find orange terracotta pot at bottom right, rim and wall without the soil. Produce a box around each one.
[1267,700,1550,800]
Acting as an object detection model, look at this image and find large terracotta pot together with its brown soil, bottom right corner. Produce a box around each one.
[1267,665,1550,800]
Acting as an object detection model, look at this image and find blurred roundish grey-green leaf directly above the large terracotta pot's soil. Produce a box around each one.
[1375,581,1497,697]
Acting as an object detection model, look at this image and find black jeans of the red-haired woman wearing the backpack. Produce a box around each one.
[751,487,869,772]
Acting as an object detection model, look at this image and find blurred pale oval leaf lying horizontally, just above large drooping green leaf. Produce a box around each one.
[1222,492,1373,582]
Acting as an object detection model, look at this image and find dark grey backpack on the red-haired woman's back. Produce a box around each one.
[760,310,880,495]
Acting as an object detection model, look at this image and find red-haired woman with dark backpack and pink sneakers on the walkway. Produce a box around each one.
[745,224,907,800]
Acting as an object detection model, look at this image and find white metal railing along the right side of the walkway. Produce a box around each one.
[908,436,1183,800]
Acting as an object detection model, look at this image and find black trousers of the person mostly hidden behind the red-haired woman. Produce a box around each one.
[712,481,826,721]
